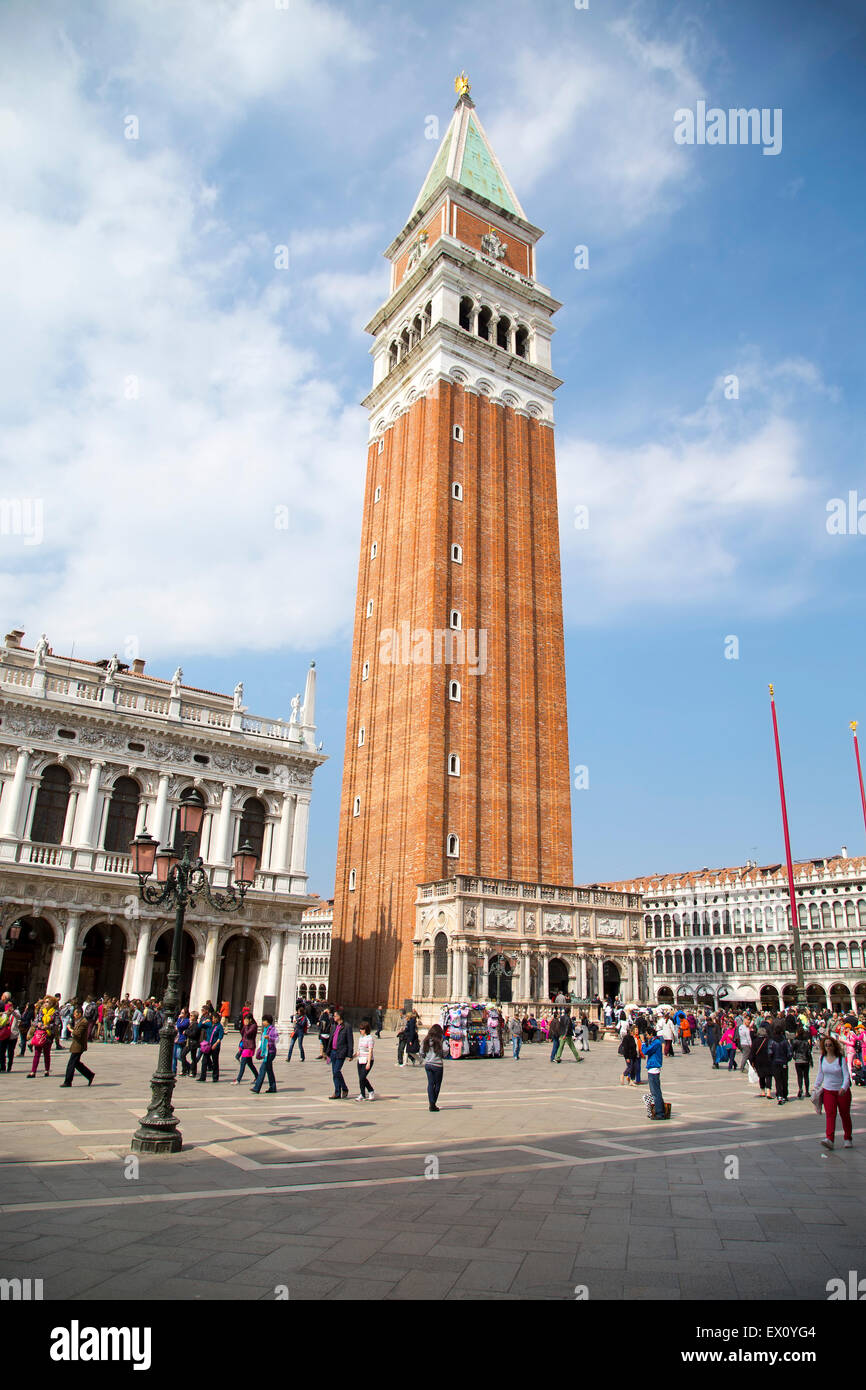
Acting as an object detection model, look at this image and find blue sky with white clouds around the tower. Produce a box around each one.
[0,0,866,895]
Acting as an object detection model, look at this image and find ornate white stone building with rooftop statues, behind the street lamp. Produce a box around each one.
[0,631,325,1020]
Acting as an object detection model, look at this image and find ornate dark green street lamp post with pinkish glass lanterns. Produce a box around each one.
[129,798,256,1154]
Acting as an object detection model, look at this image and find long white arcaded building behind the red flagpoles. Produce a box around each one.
[610,847,866,1009]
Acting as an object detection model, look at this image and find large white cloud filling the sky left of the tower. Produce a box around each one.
[0,3,366,659]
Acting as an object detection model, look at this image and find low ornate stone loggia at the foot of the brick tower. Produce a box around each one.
[414,874,651,1022]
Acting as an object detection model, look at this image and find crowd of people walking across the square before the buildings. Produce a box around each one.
[0,992,866,1148]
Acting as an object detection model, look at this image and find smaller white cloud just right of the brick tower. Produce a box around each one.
[557,357,827,626]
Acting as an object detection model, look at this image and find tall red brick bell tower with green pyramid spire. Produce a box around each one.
[331,75,571,1008]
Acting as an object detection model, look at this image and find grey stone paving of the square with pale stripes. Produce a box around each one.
[0,1036,866,1301]
